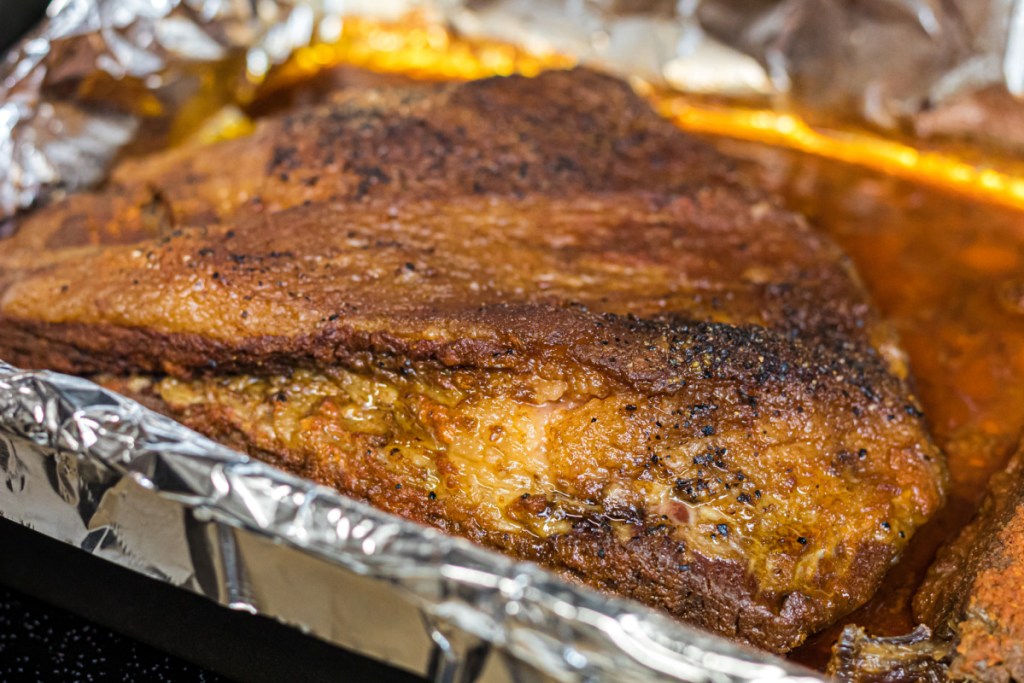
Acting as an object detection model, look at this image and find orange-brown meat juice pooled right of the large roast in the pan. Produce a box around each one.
[718,139,1024,668]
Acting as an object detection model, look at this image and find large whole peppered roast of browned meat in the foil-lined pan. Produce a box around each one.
[0,71,943,651]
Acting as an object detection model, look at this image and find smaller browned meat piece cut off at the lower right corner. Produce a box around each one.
[829,445,1024,683]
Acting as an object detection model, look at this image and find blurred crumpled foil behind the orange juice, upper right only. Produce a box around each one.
[438,0,1024,141]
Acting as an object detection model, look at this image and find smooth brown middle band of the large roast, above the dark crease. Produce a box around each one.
[0,186,902,385]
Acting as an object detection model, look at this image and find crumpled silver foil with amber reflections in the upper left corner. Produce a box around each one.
[0,0,423,217]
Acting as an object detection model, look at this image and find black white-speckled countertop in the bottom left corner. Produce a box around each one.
[0,586,227,683]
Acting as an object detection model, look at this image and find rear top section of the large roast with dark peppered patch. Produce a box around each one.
[14,70,733,248]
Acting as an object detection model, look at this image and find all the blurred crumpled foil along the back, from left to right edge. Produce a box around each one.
[0,0,1024,218]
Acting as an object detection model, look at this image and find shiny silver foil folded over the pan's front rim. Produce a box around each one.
[0,362,821,683]
